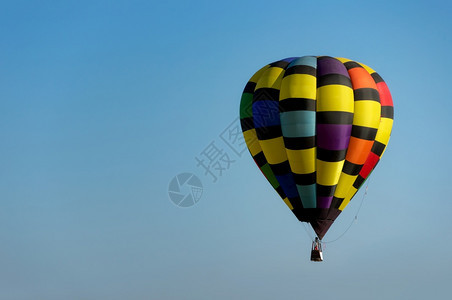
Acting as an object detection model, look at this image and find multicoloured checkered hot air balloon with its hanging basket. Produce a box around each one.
[240,56,394,261]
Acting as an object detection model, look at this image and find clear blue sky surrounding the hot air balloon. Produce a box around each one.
[0,0,452,300]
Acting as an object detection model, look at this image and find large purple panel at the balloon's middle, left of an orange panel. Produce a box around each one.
[317,124,352,150]
